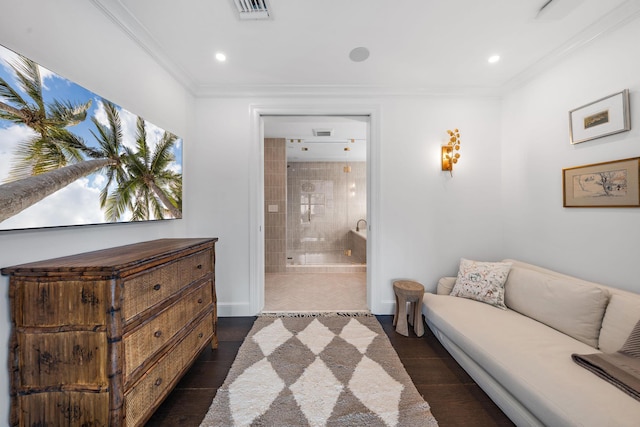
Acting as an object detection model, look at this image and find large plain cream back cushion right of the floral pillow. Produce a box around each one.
[505,267,609,348]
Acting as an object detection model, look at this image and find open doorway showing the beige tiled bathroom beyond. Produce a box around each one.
[262,115,370,311]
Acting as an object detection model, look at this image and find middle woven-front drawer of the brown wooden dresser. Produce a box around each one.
[123,281,213,385]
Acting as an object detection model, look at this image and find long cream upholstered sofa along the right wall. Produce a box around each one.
[423,260,640,427]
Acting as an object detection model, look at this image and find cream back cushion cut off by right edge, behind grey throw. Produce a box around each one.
[598,293,640,353]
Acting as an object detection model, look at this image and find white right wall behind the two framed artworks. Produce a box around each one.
[502,19,640,292]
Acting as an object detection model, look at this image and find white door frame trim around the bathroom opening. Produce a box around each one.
[249,104,382,315]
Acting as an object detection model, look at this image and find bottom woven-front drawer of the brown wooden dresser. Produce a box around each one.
[124,314,213,426]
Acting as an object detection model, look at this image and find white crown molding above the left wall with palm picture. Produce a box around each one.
[91,0,197,96]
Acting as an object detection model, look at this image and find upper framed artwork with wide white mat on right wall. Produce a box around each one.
[569,89,631,144]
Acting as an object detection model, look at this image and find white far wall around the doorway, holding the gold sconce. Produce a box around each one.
[195,97,503,316]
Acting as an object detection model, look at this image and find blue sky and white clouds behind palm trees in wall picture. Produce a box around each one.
[0,46,182,230]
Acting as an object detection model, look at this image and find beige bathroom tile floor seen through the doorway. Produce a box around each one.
[263,272,369,312]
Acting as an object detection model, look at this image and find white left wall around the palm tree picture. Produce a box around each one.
[0,0,194,425]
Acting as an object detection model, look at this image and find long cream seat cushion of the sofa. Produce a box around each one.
[423,293,640,427]
